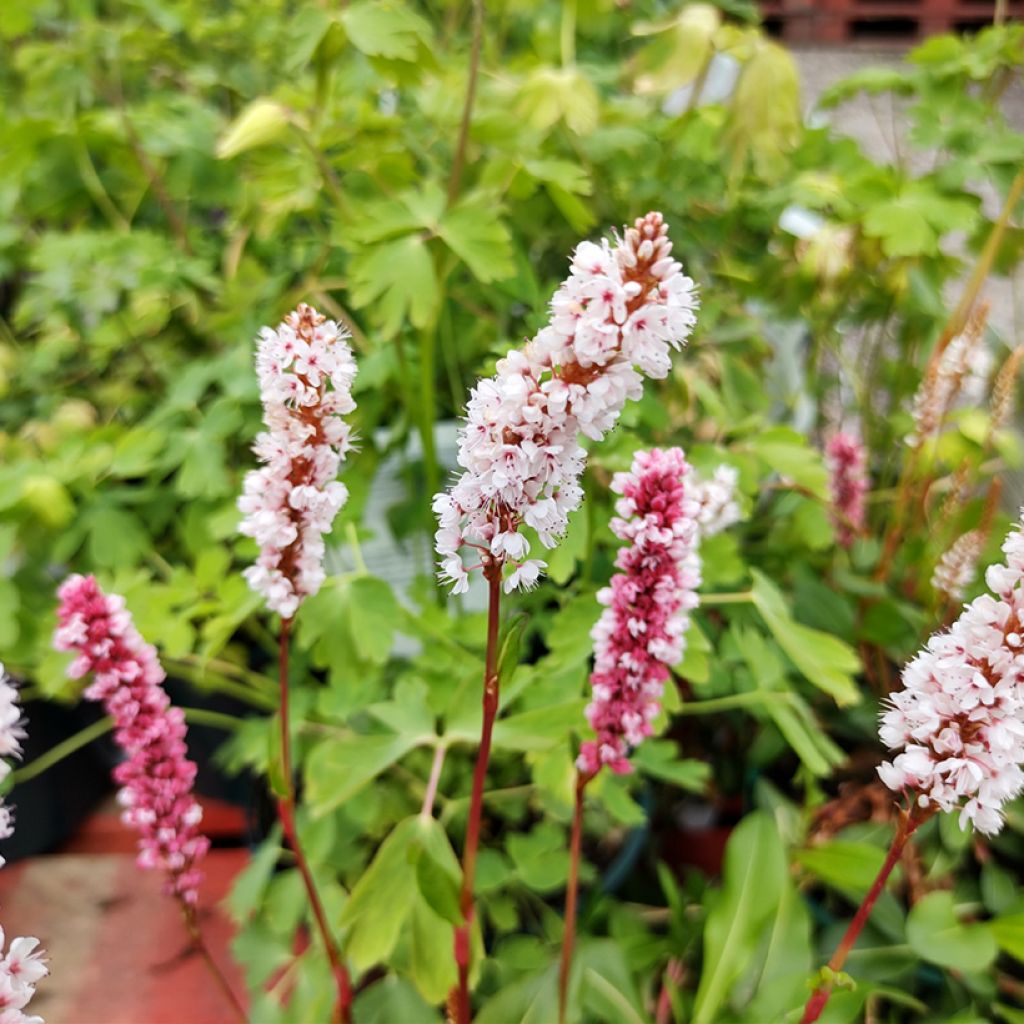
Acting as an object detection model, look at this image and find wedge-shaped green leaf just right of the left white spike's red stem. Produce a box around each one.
[305,733,432,815]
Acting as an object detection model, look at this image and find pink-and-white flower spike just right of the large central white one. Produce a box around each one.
[577,447,700,775]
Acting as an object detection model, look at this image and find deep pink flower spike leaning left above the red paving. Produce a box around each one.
[53,575,210,904]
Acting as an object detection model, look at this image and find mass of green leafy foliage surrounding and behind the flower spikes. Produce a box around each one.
[0,0,1024,1022]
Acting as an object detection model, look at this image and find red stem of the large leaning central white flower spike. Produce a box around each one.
[449,562,502,1024]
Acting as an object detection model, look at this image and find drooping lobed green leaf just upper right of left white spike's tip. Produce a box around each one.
[349,234,441,338]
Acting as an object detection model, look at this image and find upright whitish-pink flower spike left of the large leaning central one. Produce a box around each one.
[239,304,355,618]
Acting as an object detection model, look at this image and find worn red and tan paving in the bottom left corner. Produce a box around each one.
[0,802,248,1024]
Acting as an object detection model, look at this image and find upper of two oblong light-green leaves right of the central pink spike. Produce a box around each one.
[751,569,861,707]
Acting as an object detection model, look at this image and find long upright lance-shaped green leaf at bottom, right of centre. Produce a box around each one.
[692,811,787,1024]
